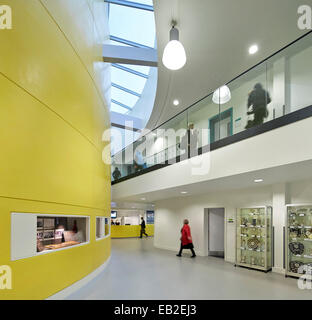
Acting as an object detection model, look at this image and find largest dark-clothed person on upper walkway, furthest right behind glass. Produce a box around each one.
[245,83,272,129]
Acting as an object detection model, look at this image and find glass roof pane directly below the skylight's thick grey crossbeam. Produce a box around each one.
[111,67,146,92]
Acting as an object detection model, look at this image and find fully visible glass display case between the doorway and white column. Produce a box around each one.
[236,206,272,272]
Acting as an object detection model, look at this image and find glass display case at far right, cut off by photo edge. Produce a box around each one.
[285,205,312,277]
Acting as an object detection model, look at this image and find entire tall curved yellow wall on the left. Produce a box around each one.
[0,0,111,300]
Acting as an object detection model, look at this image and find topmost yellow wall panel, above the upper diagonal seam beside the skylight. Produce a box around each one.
[41,0,110,114]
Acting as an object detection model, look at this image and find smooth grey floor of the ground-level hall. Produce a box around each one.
[68,238,312,300]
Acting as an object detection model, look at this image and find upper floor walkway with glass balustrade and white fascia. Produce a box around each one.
[112,32,312,200]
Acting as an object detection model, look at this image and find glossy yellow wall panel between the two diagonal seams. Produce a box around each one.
[0,0,107,149]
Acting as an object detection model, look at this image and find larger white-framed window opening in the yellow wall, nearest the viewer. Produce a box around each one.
[11,212,90,261]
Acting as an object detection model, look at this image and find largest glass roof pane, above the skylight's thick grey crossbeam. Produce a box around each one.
[109,3,156,48]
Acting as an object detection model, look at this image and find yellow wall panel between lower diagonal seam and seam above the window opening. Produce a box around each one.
[0,76,110,208]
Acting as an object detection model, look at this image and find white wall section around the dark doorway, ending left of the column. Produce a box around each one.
[154,187,272,262]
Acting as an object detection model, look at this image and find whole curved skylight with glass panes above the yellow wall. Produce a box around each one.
[104,0,157,154]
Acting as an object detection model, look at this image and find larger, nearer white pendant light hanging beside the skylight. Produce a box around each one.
[162,25,186,70]
